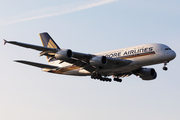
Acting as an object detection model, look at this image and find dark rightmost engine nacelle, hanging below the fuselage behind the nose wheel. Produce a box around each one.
[138,68,157,80]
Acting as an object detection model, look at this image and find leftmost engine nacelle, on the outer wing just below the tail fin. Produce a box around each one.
[55,49,73,60]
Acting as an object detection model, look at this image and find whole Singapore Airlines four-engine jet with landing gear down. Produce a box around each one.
[4,32,176,82]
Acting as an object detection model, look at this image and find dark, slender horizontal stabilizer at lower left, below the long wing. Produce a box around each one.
[15,60,58,69]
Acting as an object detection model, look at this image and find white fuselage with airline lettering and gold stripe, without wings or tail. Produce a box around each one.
[44,44,176,76]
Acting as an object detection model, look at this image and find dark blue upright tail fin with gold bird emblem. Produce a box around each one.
[39,32,60,49]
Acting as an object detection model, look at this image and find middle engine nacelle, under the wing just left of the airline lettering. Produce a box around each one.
[89,56,107,66]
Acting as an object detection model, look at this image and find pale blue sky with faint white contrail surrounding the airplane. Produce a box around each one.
[0,0,180,120]
